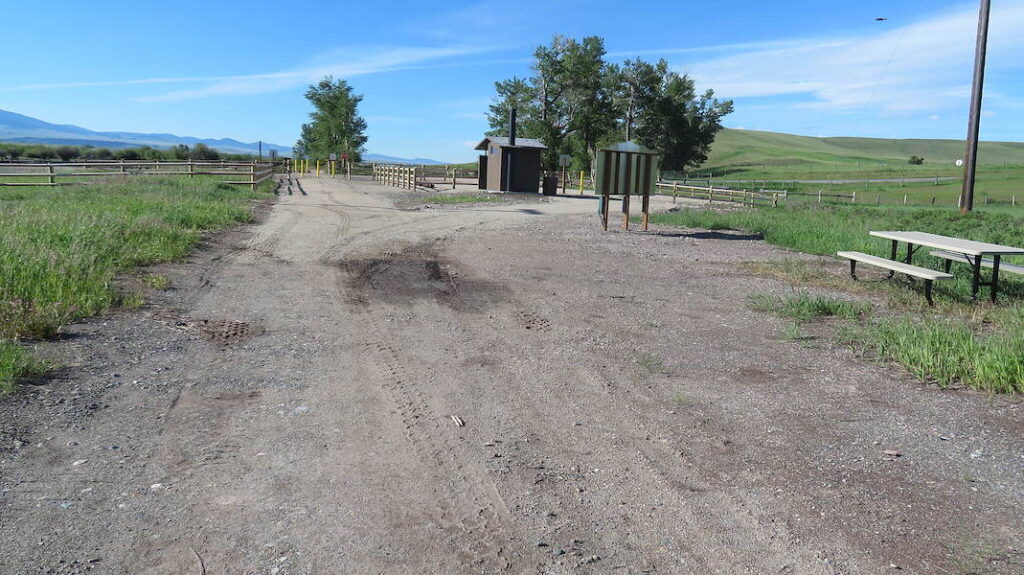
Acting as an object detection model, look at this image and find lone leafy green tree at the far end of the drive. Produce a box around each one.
[296,76,367,162]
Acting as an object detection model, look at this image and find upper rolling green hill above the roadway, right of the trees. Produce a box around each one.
[700,128,1024,171]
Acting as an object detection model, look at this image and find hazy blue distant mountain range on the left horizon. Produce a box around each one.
[0,109,444,165]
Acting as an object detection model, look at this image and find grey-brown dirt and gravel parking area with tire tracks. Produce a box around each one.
[0,179,1024,575]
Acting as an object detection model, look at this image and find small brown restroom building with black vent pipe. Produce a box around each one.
[476,136,548,193]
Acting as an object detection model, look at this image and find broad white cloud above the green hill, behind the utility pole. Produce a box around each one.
[681,1,1024,114]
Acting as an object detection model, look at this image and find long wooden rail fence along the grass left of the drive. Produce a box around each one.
[0,161,274,189]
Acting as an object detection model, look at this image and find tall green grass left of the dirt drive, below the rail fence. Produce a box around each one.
[0,176,270,388]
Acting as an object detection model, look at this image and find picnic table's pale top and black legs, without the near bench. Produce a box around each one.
[868,231,1024,302]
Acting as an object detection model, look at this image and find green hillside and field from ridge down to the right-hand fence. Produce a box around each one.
[663,129,1024,206]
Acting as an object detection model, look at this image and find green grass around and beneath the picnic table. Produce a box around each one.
[651,205,1024,393]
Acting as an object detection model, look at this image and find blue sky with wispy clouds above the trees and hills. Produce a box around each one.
[0,0,1024,162]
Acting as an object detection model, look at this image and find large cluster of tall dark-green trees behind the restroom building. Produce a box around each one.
[487,36,732,170]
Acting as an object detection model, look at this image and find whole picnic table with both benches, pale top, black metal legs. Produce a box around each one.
[837,231,1024,305]
